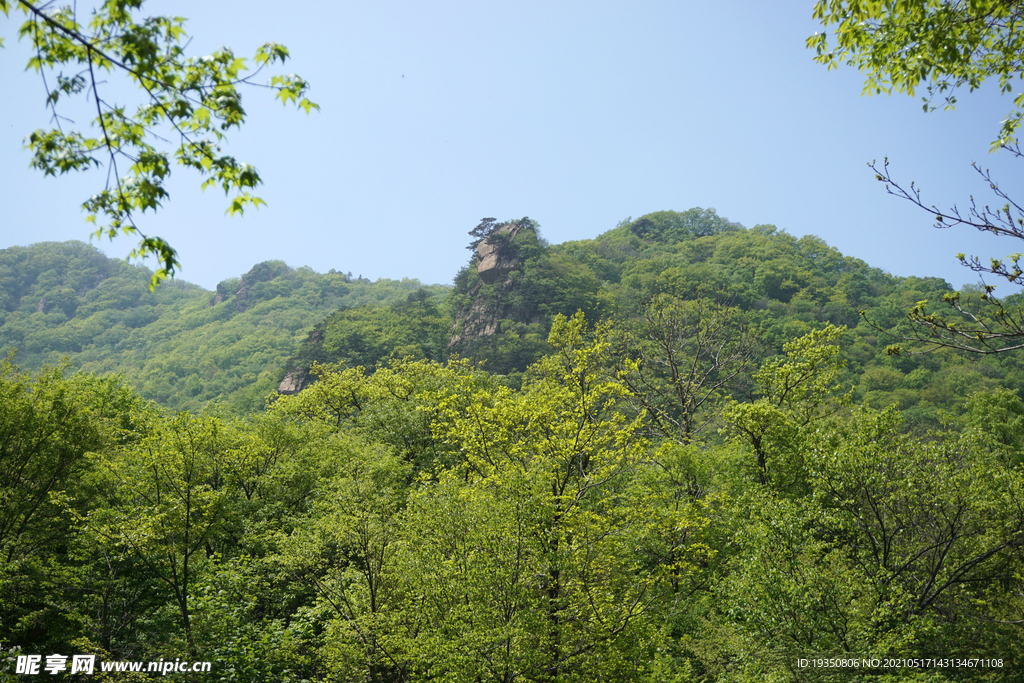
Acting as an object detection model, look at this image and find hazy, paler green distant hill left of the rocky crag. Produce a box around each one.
[0,242,445,414]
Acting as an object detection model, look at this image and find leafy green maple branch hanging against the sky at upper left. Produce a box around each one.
[9,1,318,286]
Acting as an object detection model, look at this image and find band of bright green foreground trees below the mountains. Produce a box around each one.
[0,307,1024,682]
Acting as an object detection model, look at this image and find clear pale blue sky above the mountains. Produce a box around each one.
[0,0,1024,289]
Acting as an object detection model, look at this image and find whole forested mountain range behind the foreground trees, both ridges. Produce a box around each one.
[0,214,1024,428]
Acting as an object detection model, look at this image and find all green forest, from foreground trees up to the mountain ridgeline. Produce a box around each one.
[0,209,1024,682]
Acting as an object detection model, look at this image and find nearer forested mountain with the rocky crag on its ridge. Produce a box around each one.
[276,208,1024,430]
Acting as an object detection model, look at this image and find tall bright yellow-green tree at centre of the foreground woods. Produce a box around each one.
[387,314,667,680]
